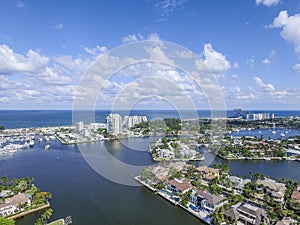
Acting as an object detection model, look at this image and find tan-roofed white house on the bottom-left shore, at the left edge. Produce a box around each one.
[0,193,31,217]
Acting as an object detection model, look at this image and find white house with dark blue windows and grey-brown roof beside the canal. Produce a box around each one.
[190,190,227,213]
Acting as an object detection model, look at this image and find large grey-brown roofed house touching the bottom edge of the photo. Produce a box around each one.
[224,203,270,225]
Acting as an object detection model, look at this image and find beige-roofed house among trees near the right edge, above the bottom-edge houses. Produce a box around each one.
[257,178,286,203]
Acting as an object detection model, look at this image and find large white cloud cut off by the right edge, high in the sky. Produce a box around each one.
[269,10,300,54]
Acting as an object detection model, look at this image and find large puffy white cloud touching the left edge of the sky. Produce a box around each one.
[0,45,49,74]
